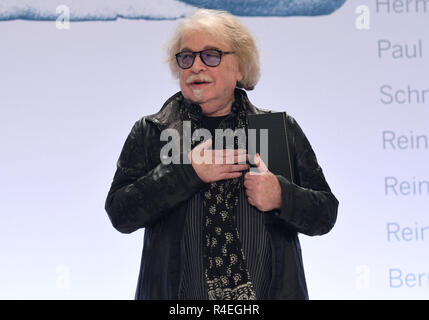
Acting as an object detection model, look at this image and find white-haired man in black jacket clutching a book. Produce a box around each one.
[105,9,338,300]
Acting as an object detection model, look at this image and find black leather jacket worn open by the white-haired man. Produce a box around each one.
[105,90,338,299]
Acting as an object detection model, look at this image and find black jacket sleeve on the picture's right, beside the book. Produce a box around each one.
[276,117,338,236]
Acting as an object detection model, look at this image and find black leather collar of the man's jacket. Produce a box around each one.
[146,88,263,129]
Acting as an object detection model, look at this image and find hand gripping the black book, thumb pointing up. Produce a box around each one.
[244,154,282,211]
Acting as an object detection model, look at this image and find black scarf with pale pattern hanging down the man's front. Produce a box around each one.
[181,90,256,300]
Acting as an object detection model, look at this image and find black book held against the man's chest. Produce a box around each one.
[247,112,294,182]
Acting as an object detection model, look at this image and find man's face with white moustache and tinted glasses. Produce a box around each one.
[179,31,242,116]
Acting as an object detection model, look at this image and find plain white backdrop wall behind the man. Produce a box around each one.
[0,0,429,299]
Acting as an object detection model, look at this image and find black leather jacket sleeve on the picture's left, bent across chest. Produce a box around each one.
[105,118,204,233]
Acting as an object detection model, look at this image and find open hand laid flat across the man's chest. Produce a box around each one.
[188,139,249,183]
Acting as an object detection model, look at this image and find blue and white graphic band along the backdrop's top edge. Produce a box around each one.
[0,0,346,21]
